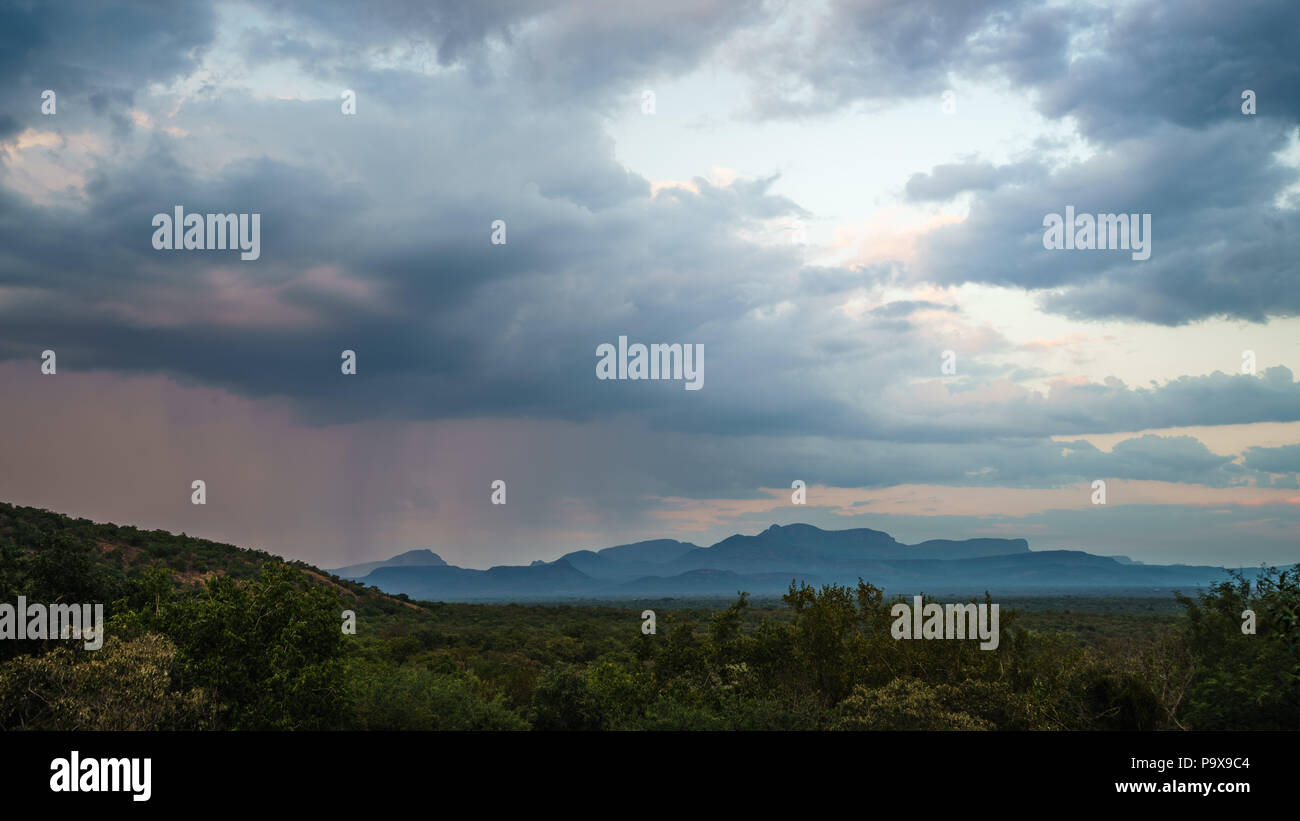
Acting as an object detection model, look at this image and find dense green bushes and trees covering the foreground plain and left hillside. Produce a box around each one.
[0,504,1300,730]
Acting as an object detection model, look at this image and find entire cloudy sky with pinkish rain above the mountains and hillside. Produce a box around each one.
[0,0,1300,568]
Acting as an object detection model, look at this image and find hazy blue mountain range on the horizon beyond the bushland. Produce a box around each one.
[329,524,1248,601]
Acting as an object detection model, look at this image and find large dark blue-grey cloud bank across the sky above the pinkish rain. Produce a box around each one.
[0,113,1300,443]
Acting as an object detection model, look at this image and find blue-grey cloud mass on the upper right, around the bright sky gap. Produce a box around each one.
[744,0,1300,325]
